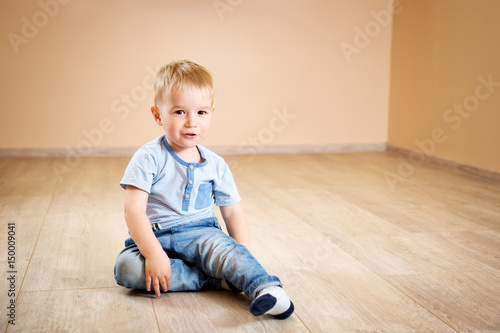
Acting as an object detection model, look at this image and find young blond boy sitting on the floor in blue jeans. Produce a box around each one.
[115,61,294,319]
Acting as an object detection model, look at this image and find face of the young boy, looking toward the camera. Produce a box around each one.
[151,86,214,152]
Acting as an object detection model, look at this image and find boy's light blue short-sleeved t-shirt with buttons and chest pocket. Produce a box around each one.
[120,136,241,226]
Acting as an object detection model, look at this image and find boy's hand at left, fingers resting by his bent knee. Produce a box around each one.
[145,252,172,297]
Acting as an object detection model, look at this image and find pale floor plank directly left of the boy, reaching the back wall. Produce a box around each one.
[23,158,128,291]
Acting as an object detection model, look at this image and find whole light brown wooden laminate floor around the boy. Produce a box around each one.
[0,153,500,333]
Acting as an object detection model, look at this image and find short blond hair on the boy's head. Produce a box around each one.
[154,60,215,105]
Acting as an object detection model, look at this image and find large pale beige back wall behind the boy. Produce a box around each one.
[0,0,392,149]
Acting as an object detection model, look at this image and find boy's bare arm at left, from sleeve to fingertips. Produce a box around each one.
[125,185,172,297]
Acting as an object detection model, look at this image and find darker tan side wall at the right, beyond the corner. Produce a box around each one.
[388,0,500,171]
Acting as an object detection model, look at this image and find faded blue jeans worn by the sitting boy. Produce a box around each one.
[115,217,281,299]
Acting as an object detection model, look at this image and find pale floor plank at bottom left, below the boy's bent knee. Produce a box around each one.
[8,287,159,332]
